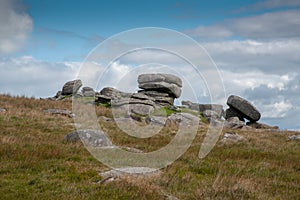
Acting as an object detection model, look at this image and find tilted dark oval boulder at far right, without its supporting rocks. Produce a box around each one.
[227,95,261,122]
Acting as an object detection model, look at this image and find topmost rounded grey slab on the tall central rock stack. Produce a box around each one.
[138,74,182,87]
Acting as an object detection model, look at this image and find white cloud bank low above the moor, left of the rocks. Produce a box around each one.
[0,56,80,97]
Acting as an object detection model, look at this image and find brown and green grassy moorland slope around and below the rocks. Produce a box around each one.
[0,95,300,200]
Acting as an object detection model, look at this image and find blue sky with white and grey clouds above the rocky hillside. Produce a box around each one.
[0,0,300,130]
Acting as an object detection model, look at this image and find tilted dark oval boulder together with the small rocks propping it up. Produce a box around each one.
[225,95,261,123]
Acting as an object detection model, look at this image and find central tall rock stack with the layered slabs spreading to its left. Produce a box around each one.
[96,74,182,115]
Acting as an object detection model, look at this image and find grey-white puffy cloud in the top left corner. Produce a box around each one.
[0,0,33,55]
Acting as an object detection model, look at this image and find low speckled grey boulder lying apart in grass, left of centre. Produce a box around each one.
[64,130,113,147]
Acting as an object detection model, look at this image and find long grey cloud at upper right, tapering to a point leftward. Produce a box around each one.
[185,9,300,40]
